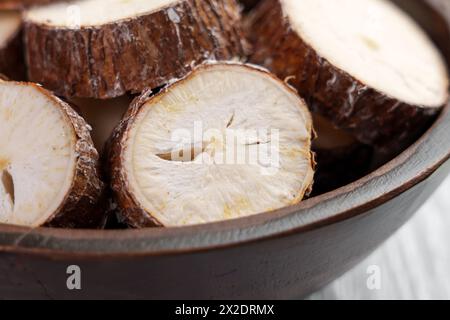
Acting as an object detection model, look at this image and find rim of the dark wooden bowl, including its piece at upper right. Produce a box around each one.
[0,0,450,254]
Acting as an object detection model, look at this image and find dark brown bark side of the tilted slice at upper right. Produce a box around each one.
[246,0,442,149]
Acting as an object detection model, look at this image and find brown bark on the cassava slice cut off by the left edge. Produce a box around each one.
[14,83,106,229]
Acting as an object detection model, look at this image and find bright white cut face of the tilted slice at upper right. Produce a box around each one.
[280,0,448,107]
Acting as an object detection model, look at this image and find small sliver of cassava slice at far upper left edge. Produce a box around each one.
[0,11,25,80]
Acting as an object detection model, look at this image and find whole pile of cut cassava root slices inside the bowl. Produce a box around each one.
[0,0,449,229]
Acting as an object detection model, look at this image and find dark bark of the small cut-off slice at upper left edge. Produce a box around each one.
[0,29,26,80]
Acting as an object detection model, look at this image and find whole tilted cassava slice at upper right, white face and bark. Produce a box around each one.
[247,0,448,146]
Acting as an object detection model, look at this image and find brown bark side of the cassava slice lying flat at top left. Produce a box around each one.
[25,0,248,99]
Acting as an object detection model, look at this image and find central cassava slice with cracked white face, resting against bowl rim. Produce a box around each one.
[109,63,314,228]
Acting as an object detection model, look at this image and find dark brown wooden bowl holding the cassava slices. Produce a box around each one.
[0,0,450,299]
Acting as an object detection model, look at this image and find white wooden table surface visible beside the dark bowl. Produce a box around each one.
[311,175,450,300]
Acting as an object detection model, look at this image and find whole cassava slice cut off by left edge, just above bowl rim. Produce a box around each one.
[0,80,105,228]
